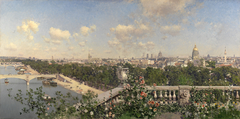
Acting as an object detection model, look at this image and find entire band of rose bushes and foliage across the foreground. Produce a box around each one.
[9,77,240,119]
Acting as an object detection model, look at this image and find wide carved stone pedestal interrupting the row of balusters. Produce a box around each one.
[178,85,190,106]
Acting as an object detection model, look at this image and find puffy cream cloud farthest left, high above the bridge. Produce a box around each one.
[17,20,40,41]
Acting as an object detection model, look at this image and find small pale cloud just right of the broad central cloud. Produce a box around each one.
[160,25,182,36]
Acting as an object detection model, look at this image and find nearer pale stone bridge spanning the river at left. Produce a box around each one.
[0,74,58,85]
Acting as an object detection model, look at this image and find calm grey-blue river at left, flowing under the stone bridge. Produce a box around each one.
[0,66,82,119]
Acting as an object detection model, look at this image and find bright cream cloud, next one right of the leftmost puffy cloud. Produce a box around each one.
[49,27,71,41]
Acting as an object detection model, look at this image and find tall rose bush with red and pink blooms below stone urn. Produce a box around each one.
[116,76,160,118]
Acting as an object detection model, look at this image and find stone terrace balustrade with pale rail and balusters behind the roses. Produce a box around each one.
[96,85,240,105]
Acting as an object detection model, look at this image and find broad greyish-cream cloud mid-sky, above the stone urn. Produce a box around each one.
[108,20,153,54]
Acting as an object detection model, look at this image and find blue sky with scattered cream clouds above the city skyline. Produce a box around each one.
[0,0,240,59]
